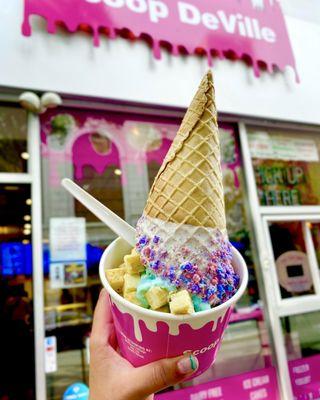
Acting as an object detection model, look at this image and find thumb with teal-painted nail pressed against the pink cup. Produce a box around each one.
[132,354,199,399]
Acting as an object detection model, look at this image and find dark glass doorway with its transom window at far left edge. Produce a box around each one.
[0,106,35,400]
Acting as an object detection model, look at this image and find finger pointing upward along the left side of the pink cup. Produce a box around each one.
[90,289,113,345]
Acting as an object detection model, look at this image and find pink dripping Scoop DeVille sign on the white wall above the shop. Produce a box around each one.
[22,0,298,81]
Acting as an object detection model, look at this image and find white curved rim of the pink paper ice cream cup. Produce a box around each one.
[99,237,248,322]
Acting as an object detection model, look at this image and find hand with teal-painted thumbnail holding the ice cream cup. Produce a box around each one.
[89,289,198,400]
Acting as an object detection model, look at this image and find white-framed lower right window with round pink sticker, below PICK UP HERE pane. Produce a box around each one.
[263,214,320,399]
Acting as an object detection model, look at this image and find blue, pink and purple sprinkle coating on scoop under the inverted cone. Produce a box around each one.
[136,217,239,306]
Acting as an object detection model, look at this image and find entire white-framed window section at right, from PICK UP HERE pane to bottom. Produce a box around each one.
[240,124,320,400]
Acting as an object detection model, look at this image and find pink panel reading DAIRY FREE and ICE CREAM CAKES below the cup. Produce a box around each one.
[155,367,280,400]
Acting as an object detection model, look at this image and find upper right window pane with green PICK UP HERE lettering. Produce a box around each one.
[248,127,320,206]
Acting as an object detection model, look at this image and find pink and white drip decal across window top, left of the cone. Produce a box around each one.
[41,110,178,187]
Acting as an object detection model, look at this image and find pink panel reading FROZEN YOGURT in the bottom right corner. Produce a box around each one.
[289,355,320,400]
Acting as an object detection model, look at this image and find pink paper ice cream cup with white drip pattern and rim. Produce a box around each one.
[99,238,248,378]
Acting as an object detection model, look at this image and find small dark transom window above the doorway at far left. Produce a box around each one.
[0,107,29,172]
